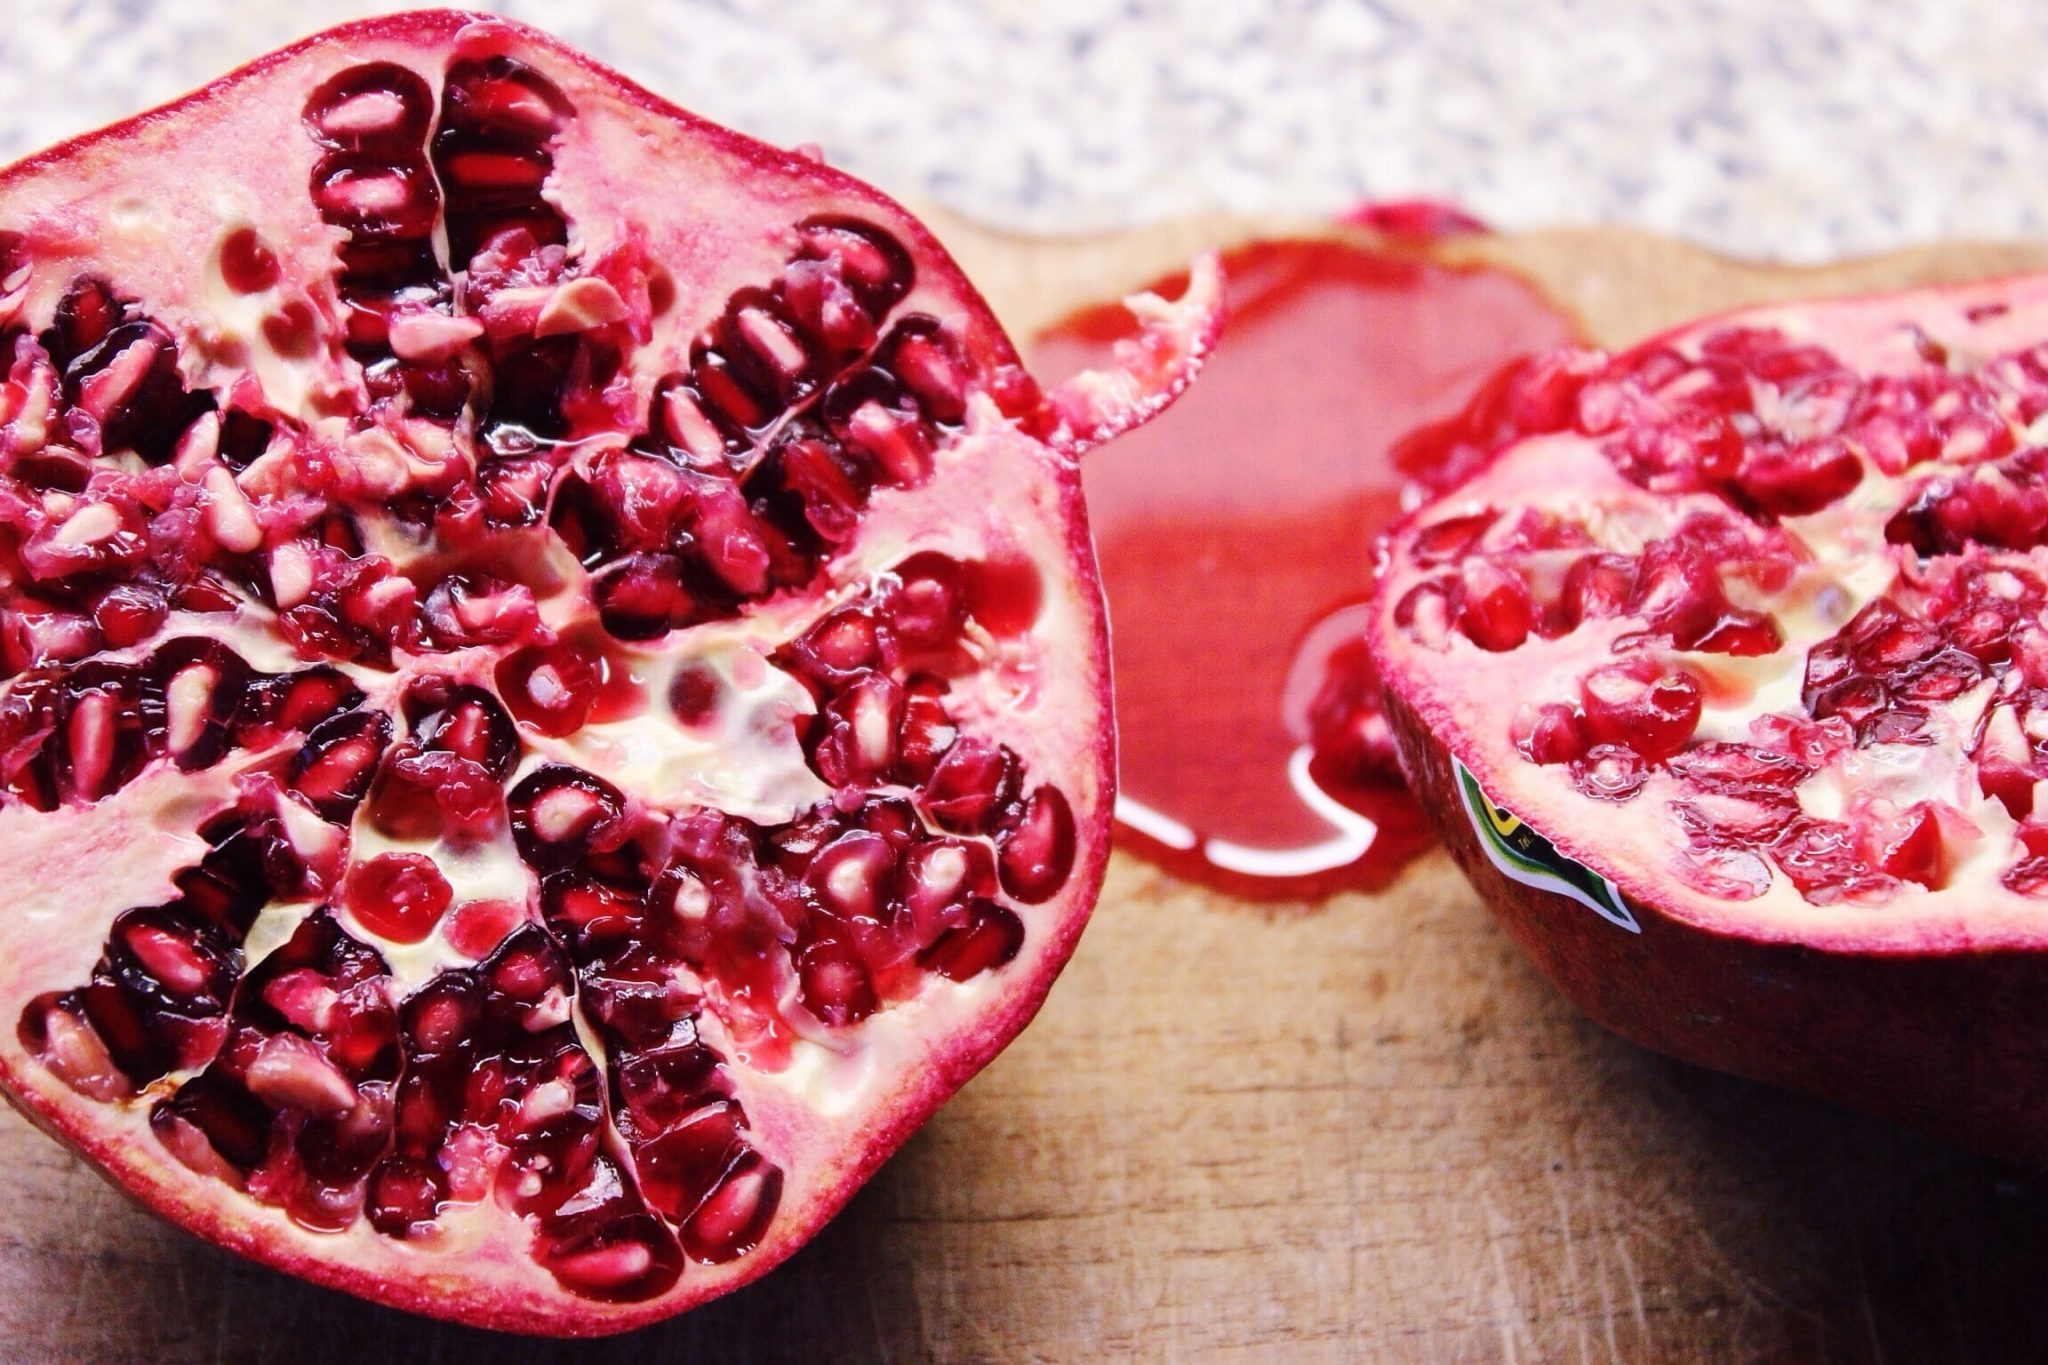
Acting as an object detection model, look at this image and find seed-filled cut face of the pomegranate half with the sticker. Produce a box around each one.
[1370,276,2048,952]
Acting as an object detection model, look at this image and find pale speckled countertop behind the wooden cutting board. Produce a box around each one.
[0,0,2048,260]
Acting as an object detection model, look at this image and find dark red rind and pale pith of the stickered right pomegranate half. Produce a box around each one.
[1366,276,2048,1160]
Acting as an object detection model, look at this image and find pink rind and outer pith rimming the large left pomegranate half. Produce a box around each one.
[0,12,1122,1336]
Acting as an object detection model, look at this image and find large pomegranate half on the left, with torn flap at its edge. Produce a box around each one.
[0,12,1217,1334]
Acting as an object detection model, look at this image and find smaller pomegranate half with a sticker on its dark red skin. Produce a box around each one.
[1366,276,2048,1158]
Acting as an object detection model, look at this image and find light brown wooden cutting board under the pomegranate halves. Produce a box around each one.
[12,221,2048,1365]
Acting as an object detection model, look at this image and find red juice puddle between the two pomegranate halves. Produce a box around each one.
[1032,241,1575,898]
